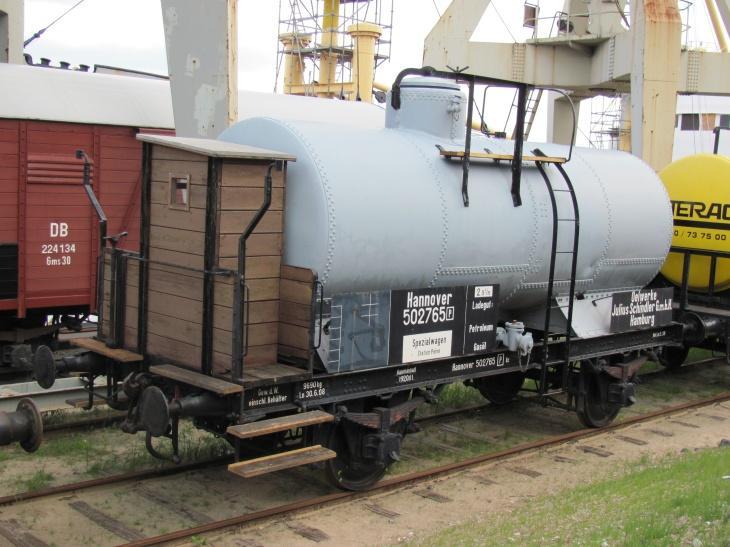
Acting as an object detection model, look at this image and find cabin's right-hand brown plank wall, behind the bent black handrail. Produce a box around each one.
[213,161,285,375]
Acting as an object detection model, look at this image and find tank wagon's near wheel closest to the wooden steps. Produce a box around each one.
[325,422,388,490]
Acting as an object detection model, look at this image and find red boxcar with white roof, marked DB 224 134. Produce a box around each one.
[0,65,172,364]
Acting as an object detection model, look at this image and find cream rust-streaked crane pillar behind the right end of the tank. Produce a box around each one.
[631,0,682,171]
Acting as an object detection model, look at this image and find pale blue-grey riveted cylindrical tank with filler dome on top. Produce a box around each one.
[220,78,672,310]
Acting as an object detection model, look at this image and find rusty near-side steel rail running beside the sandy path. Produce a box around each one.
[125,392,730,547]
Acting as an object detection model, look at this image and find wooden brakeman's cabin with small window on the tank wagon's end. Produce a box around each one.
[96,135,316,385]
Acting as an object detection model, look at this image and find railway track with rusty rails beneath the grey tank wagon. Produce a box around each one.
[0,386,730,545]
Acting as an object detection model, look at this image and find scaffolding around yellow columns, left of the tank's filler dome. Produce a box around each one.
[274,0,393,101]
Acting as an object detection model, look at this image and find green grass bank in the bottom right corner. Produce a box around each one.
[410,448,730,547]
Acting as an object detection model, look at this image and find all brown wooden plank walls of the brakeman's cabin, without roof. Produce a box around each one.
[117,145,313,377]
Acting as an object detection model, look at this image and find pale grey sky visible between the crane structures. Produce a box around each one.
[25,0,716,144]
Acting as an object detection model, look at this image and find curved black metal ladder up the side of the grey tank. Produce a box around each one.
[533,149,580,404]
